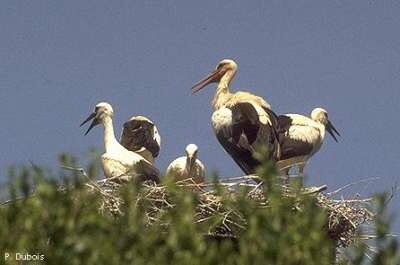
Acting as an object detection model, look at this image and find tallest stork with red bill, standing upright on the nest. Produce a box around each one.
[192,59,280,174]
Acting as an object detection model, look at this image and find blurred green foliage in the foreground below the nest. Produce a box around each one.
[0,155,398,265]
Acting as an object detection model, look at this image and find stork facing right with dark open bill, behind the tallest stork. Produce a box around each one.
[277,108,340,176]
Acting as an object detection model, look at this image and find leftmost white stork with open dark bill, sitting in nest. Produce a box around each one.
[81,102,159,182]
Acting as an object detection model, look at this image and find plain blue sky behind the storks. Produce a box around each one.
[0,0,400,231]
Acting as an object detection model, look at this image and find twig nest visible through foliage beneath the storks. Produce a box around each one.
[87,176,374,247]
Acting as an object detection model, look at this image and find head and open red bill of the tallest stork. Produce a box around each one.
[192,59,237,93]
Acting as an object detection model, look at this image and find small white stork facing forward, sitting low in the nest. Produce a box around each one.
[166,144,206,183]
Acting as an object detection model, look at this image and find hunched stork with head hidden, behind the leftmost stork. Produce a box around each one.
[121,116,161,164]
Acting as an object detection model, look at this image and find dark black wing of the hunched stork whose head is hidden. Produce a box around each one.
[121,117,160,157]
